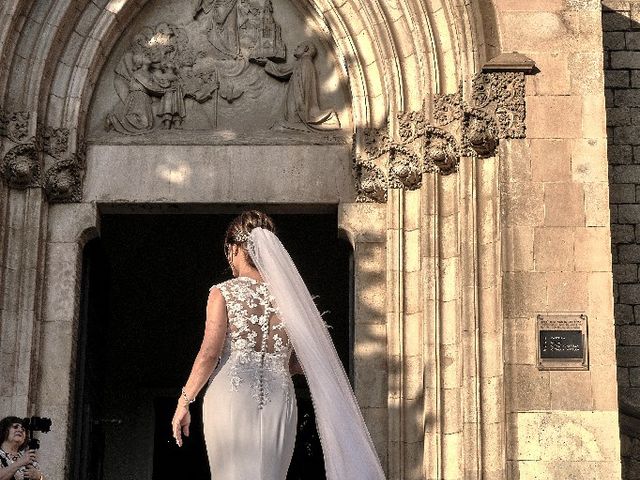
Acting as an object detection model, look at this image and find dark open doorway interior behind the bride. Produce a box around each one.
[75,208,352,480]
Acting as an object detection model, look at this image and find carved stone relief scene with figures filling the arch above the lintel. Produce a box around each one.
[94,0,344,143]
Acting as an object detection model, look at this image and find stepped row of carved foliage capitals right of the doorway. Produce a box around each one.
[353,72,525,202]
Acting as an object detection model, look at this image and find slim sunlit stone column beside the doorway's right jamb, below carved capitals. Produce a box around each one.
[386,189,424,479]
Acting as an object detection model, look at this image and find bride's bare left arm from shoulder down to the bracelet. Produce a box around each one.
[184,288,227,399]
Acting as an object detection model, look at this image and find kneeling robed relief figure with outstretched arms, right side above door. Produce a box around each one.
[252,41,340,130]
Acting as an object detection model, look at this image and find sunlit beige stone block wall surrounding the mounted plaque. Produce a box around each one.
[498,1,620,479]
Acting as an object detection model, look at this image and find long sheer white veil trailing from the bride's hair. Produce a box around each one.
[247,228,385,480]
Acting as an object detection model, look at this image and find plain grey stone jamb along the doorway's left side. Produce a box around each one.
[35,203,98,479]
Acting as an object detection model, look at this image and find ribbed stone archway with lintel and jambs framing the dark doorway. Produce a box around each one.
[0,0,523,478]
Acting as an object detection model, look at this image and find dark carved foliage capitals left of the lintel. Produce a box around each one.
[0,111,84,202]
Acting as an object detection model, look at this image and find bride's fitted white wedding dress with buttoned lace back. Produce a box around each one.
[203,277,298,480]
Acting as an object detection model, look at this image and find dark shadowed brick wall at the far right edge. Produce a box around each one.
[602,0,640,480]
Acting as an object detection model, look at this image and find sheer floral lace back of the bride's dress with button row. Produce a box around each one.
[216,277,292,407]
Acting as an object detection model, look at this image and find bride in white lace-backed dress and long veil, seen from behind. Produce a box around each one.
[172,211,385,480]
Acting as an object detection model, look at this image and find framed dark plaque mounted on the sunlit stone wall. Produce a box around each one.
[536,314,589,370]
